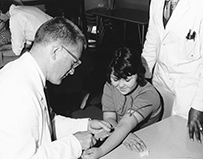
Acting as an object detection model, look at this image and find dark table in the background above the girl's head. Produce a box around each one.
[88,8,149,45]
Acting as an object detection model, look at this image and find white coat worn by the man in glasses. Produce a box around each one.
[0,53,88,159]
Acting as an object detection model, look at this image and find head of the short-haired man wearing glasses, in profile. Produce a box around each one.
[30,17,86,84]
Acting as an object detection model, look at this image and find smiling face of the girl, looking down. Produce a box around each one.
[110,73,137,95]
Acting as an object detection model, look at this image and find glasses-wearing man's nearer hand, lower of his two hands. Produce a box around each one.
[74,131,96,150]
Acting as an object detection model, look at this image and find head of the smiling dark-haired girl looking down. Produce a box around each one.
[107,47,146,95]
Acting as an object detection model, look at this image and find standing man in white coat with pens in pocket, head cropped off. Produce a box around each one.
[142,0,203,143]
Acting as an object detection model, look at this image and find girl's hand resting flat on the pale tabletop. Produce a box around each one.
[123,133,147,152]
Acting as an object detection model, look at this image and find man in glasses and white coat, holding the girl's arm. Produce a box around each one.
[0,17,110,159]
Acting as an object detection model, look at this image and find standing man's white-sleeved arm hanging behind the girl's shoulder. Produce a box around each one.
[142,1,160,78]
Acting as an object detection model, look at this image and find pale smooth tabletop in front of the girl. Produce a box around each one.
[102,116,203,159]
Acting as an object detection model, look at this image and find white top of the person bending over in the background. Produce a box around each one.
[9,4,52,55]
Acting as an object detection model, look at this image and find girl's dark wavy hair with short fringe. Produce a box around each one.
[107,47,146,86]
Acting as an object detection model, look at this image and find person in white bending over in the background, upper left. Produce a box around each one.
[0,0,52,56]
